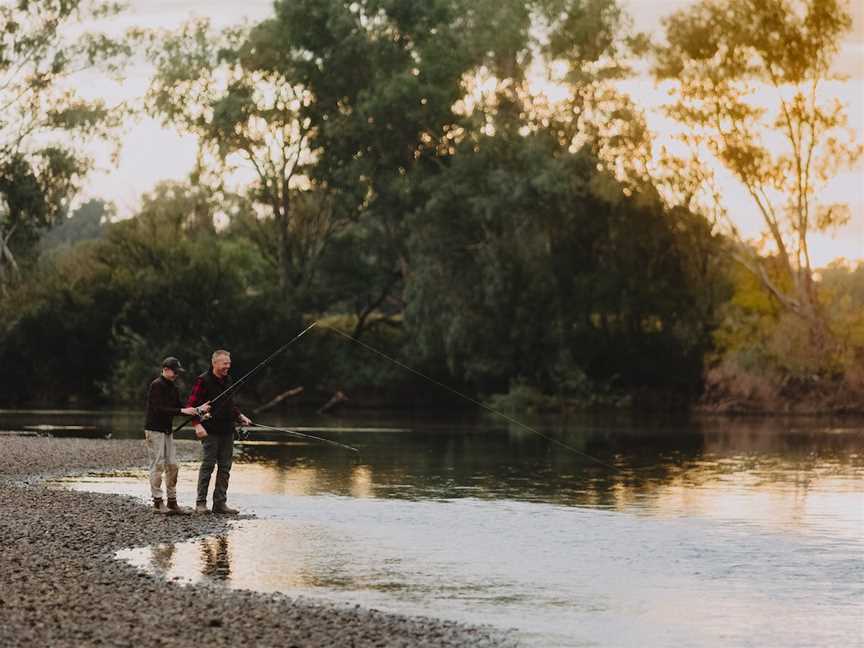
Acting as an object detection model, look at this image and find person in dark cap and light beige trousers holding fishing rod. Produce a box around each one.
[144,356,210,513]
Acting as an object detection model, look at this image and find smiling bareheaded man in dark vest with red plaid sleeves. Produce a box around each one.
[186,349,252,513]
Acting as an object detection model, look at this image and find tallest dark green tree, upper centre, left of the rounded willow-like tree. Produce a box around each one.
[257,0,480,334]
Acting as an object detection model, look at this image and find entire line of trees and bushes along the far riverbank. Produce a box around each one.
[0,0,864,409]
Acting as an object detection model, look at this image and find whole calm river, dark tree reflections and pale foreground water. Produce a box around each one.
[15,413,864,648]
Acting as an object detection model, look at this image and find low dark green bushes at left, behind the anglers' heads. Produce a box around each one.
[0,184,291,402]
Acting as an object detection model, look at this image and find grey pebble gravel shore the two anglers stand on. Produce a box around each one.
[0,436,516,648]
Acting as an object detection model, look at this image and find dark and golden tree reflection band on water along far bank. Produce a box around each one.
[224,421,864,520]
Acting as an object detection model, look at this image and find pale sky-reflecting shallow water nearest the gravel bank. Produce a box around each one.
[98,476,864,646]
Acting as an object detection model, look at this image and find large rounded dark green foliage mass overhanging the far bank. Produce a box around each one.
[406,129,722,398]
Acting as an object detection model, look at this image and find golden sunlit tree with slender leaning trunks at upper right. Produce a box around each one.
[654,0,862,360]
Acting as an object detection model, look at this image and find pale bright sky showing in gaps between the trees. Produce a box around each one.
[72,0,864,266]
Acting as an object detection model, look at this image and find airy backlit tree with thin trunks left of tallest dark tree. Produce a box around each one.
[147,20,344,301]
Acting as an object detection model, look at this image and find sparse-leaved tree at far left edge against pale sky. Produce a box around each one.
[0,0,129,293]
